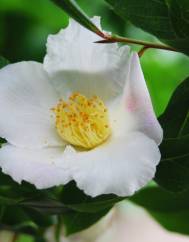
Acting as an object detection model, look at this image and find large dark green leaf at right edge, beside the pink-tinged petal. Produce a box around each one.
[155,78,189,192]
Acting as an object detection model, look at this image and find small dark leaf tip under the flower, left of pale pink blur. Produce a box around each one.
[63,209,109,235]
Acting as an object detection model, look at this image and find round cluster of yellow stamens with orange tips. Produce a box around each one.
[52,93,111,149]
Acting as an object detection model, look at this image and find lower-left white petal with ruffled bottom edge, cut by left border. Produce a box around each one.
[0,144,73,189]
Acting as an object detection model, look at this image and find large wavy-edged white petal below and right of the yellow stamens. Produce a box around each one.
[64,133,160,197]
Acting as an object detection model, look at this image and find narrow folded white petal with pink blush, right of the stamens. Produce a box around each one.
[124,53,163,144]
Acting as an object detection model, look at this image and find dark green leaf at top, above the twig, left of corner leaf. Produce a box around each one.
[106,0,174,39]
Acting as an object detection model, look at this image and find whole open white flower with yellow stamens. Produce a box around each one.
[0,18,162,196]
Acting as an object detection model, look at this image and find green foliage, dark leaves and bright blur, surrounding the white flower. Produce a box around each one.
[0,0,189,242]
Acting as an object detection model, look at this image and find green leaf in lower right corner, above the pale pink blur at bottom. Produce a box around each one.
[129,187,189,234]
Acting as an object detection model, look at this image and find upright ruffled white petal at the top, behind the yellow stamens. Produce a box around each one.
[44,18,129,101]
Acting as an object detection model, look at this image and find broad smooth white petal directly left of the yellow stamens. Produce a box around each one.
[0,62,63,147]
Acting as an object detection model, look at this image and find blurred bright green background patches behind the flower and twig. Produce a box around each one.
[0,0,189,242]
